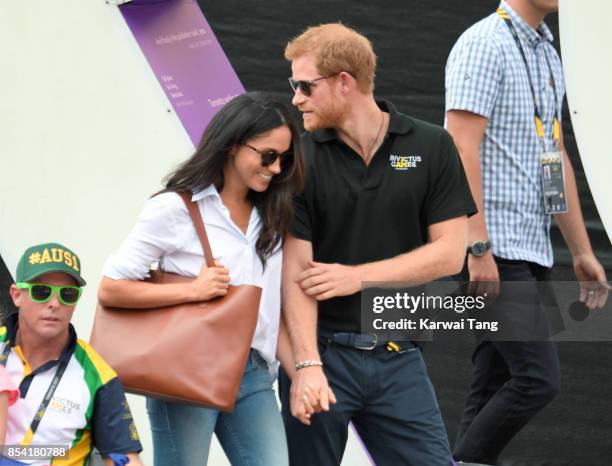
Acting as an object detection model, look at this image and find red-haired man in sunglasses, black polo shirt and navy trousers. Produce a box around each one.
[280,24,475,466]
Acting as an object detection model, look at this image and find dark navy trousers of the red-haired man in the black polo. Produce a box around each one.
[279,339,452,466]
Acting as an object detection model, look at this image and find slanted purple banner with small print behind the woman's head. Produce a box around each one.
[120,0,244,145]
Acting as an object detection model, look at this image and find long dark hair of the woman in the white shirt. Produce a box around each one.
[161,92,304,267]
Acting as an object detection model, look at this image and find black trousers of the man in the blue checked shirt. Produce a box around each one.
[453,258,560,464]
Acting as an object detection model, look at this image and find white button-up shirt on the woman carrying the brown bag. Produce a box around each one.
[103,186,282,363]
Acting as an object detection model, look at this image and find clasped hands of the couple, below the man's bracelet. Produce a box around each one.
[291,366,336,426]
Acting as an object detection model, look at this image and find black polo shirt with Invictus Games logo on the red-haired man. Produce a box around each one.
[290,101,476,332]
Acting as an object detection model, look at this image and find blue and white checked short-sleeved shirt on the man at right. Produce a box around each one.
[446,1,565,267]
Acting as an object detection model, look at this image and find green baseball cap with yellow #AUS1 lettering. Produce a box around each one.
[15,243,85,286]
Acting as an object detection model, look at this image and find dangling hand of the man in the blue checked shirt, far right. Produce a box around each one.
[574,254,610,309]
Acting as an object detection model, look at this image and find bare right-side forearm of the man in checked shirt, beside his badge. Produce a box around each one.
[555,151,593,257]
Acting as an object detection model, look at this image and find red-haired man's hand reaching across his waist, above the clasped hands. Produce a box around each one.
[296,261,361,301]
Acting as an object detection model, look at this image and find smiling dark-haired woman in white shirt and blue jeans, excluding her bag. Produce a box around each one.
[98,92,304,466]
